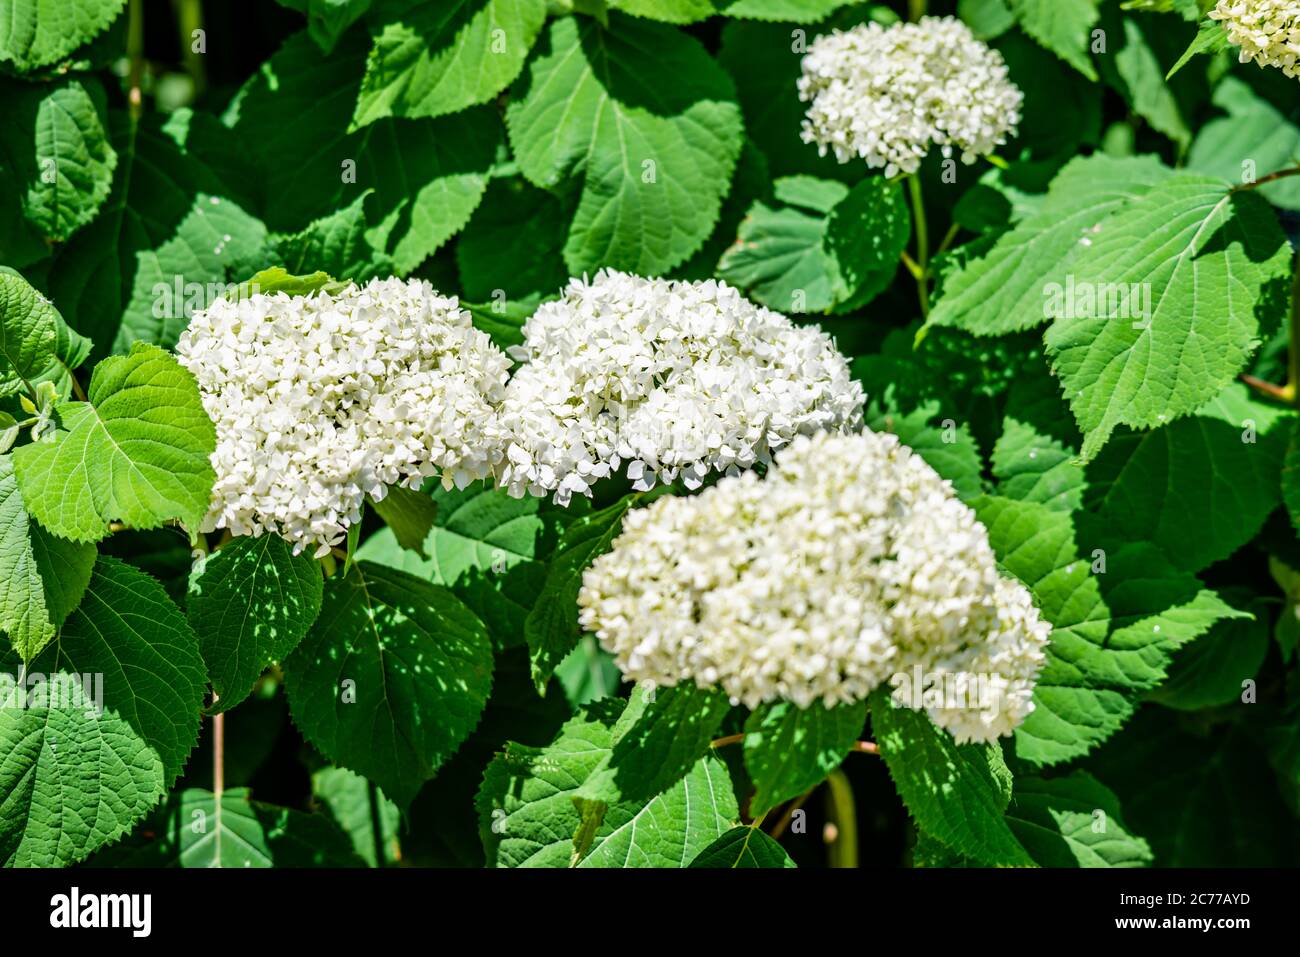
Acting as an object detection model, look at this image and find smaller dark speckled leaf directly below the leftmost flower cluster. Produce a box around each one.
[186,533,324,713]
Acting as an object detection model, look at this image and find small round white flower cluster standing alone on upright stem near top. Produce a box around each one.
[798,17,1024,177]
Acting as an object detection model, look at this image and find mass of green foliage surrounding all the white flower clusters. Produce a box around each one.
[0,0,1300,873]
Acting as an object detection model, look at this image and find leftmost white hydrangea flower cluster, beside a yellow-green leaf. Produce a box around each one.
[177,278,510,557]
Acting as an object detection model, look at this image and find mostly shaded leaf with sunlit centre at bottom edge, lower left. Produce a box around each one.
[95,788,361,867]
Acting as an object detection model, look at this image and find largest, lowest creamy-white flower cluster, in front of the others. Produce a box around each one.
[579,430,1050,741]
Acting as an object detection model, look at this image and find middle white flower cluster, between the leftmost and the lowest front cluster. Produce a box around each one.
[497,269,865,505]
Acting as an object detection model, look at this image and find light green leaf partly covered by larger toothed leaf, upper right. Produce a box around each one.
[930,155,1170,335]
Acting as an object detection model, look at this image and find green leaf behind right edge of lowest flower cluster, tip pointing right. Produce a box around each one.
[976,498,1245,765]
